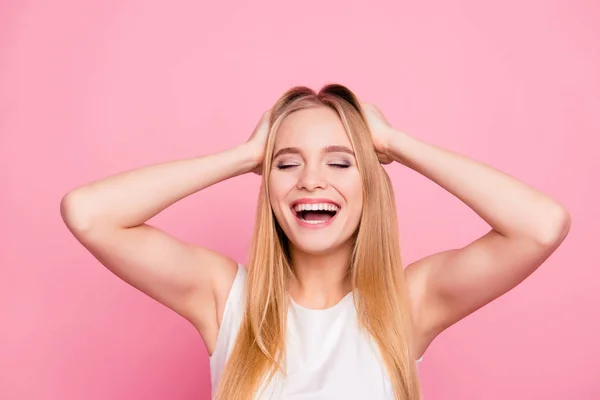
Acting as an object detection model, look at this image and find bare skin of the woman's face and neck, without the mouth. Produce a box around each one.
[269,107,363,308]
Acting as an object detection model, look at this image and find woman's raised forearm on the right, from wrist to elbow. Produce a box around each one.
[388,131,568,243]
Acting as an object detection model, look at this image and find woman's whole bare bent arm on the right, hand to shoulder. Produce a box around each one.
[363,104,571,354]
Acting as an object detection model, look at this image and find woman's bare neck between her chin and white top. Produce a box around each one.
[289,244,352,309]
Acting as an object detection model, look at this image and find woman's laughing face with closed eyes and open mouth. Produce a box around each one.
[268,107,363,253]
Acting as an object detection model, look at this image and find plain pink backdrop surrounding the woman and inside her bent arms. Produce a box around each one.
[0,0,600,400]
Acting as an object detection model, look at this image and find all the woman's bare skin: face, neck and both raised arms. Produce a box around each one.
[60,104,570,356]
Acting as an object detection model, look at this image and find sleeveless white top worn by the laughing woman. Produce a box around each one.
[210,265,420,400]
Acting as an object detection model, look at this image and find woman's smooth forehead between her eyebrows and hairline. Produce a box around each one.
[275,107,352,151]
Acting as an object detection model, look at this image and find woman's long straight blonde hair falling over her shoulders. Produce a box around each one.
[216,84,420,400]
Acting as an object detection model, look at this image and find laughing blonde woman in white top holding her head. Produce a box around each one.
[61,84,570,400]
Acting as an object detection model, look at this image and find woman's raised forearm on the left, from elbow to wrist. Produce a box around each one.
[61,145,256,229]
